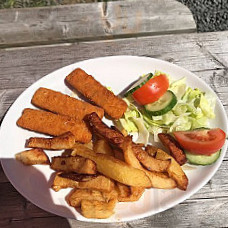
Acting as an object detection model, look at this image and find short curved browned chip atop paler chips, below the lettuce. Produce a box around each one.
[133,145,170,172]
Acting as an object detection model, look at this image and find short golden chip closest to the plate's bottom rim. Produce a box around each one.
[81,199,117,219]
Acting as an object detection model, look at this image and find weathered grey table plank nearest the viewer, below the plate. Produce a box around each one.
[5,195,228,228]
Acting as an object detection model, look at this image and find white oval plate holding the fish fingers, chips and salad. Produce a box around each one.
[0,56,228,222]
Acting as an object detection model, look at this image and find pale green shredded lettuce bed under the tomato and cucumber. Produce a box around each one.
[119,71,216,144]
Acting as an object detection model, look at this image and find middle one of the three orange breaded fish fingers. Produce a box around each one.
[32,88,104,120]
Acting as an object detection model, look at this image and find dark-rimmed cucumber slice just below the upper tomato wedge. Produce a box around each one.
[144,90,177,116]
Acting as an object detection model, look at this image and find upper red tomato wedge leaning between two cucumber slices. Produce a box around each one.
[132,74,169,105]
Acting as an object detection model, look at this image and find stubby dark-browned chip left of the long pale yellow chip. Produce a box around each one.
[50,156,96,174]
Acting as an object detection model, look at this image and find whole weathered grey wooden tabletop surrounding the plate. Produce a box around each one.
[0,32,228,228]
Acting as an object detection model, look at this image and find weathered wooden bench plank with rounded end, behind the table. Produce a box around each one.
[0,0,196,46]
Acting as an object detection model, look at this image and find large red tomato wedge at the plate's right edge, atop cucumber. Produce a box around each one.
[173,128,226,155]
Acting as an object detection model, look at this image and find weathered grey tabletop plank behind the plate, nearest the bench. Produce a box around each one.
[0,32,228,89]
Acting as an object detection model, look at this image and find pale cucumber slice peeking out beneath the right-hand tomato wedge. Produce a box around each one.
[185,150,221,165]
